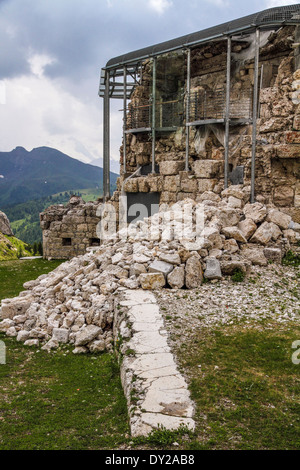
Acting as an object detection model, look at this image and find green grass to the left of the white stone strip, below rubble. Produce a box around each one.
[0,335,129,450]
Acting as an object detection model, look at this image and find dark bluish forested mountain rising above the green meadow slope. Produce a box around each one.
[0,147,118,206]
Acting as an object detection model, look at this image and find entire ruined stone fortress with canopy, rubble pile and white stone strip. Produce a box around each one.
[0,5,300,436]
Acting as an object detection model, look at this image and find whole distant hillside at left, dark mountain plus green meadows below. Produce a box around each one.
[0,147,118,245]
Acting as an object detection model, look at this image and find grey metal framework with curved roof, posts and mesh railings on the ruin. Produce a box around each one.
[99,4,300,202]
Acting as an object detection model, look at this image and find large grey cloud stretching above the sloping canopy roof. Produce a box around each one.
[0,0,261,82]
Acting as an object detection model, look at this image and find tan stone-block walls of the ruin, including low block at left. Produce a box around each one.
[41,26,300,259]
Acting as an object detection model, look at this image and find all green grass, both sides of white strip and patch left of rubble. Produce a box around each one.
[0,260,300,450]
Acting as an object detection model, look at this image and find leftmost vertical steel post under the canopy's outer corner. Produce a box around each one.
[103,71,110,200]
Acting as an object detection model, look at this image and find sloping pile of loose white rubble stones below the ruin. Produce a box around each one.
[0,186,300,353]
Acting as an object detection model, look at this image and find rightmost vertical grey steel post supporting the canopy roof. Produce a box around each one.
[251,28,260,204]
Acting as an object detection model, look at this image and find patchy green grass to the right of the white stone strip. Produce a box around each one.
[179,325,300,450]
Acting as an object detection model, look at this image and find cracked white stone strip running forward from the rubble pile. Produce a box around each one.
[115,289,195,436]
